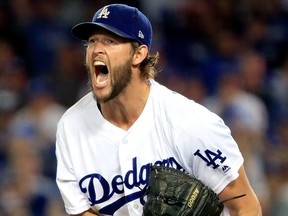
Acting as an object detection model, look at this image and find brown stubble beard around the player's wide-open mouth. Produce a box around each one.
[86,60,132,103]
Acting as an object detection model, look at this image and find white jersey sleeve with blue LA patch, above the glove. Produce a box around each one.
[174,105,244,193]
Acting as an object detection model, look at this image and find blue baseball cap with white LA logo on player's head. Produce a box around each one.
[72,4,152,50]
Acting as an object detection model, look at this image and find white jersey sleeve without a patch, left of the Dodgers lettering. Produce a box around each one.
[56,122,90,214]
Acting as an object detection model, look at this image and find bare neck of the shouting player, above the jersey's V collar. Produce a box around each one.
[100,79,150,130]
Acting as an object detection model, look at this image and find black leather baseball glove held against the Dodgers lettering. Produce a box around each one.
[143,166,224,216]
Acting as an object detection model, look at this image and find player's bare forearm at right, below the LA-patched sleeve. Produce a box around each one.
[219,166,262,216]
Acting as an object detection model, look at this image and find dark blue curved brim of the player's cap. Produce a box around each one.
[72,22,133,40]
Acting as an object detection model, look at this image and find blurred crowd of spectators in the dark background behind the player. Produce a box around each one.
[0,0,288,216]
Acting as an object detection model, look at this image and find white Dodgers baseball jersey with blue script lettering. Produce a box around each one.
[56,80,243,216]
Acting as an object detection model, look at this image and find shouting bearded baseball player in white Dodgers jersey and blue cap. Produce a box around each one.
[56,4,261,216]
